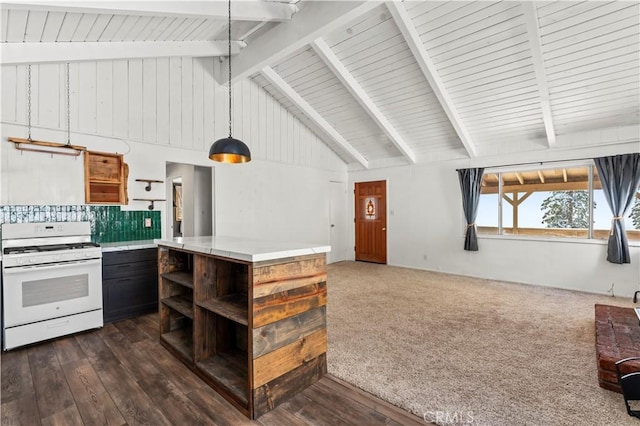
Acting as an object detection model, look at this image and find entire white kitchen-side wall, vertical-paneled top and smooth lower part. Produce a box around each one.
[0,58,347,250]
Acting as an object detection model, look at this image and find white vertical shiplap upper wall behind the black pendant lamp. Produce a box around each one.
[0,57,346,171]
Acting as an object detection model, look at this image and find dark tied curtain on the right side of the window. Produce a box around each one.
[593,154,640,263]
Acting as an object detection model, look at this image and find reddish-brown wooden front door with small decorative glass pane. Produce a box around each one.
[354,180,387,263]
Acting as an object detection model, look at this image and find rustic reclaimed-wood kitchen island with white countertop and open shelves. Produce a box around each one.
[156,237,330,419]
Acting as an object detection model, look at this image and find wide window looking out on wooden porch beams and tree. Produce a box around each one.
[476,165,640,241]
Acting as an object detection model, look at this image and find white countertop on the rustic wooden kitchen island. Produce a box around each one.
[154,236,331,262]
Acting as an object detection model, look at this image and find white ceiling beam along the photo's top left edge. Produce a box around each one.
[2,0,298,22]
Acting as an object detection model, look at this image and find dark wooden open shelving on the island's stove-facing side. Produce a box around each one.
[159,249,251,415]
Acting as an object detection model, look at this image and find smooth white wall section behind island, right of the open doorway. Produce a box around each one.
[215,162,346,244]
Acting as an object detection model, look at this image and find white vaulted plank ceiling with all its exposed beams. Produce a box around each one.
[0,0,640,169]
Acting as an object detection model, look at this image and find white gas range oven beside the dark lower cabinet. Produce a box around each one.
[2,222,103,350]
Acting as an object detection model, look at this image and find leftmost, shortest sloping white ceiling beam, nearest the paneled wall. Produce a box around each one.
[260,67,369,169]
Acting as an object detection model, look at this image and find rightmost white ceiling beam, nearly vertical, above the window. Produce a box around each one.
[522,1,556,148]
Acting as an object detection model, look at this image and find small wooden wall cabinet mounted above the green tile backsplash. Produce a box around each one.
[84,151,128,204]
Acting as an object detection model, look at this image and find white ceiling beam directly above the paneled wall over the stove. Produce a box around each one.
[0,41,244,65]
